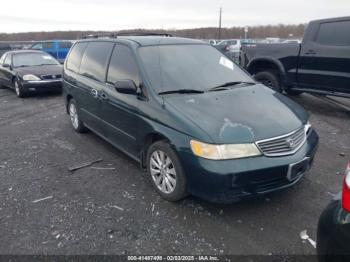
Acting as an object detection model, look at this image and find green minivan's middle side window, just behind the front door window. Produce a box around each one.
[80,42,114,82]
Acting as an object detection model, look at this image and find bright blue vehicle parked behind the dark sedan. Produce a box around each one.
[30,40,73,64]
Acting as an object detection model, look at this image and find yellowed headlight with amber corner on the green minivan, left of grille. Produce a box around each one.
[191,140,261,160]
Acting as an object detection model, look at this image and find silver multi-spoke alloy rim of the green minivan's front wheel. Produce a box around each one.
[149,150,176,194]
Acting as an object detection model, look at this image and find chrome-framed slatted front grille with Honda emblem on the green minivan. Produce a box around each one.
[256,126,310,156]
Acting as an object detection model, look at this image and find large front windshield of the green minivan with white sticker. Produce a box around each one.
[139,44,254,93]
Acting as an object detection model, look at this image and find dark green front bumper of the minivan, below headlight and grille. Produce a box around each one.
[179,130,318,203]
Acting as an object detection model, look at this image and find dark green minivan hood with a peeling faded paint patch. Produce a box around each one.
[164,84,309,144]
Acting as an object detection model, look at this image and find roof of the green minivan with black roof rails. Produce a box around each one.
[77,36,208,46]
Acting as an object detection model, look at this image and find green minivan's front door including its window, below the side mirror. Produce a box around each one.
[103,44,140,158]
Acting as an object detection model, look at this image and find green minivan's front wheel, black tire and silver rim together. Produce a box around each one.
[147,141,188,202]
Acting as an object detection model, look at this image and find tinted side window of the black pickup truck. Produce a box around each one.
[316,21,350,46]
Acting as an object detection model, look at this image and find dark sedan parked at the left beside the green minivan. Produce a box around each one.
[0,50,62,97]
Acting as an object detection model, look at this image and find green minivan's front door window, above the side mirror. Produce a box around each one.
[107,45,140,86]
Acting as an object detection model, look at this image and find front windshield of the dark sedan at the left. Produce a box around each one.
[13,53,58,67]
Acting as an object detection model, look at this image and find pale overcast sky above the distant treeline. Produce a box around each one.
[0,0,350,32]
